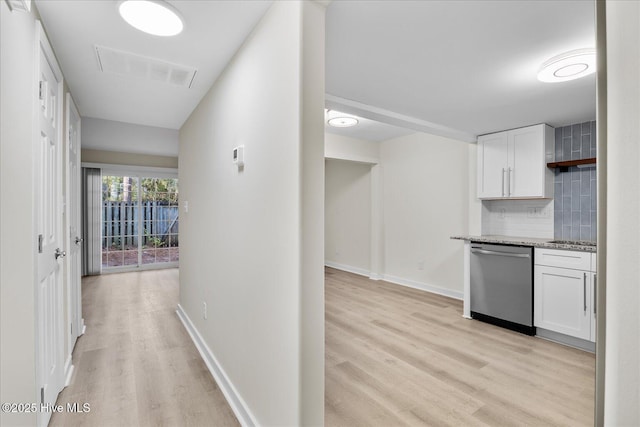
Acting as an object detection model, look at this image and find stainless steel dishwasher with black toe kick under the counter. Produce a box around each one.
[470,243,535,335]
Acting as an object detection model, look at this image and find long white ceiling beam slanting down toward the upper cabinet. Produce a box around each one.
[324,93,477,142]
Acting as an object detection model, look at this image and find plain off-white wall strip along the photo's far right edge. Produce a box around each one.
[604,1,640,426]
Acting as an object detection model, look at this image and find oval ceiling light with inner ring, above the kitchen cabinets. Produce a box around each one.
[538,49,596,83]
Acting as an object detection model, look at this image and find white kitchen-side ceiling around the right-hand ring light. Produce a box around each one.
[326,0,595,139]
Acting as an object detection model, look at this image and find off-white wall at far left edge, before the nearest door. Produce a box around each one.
[0,1,39,426]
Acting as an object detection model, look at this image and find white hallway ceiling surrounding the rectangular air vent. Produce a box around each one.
[36,0,272,129]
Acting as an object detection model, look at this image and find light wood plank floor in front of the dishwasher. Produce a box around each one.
[325,269,595,426]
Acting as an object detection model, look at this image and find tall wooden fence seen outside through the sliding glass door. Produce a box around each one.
[102,201,179,249]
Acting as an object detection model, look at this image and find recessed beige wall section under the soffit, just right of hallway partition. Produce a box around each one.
[324,159,371,275]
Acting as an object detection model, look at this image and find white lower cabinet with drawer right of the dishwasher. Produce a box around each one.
[533,248,595,341]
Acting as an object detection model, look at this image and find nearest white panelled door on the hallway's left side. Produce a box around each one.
[35,21,64,425]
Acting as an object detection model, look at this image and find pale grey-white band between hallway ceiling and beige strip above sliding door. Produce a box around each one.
[82,117,178,157]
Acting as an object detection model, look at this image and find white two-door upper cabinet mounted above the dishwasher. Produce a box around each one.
[478,124,555,199]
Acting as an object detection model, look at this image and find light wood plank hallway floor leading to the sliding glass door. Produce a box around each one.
[49,269,238,426]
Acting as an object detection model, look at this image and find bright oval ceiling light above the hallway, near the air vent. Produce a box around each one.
[118,0,184,36]
